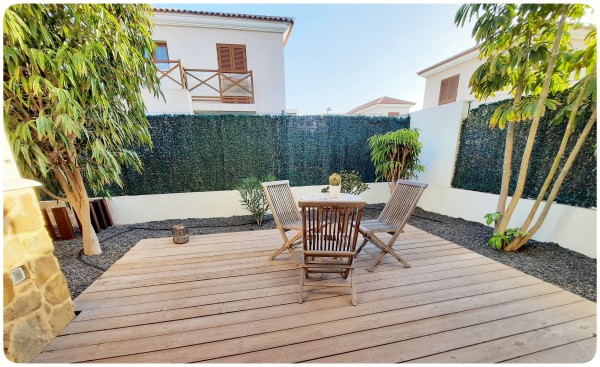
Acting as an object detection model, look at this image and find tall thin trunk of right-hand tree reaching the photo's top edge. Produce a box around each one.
[497,5,568,234]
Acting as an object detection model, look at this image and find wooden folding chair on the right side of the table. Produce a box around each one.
[356,180,427,272]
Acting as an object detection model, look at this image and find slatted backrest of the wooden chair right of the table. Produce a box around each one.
[378,180,427,230]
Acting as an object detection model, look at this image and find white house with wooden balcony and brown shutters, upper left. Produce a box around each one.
[144,9,294,114]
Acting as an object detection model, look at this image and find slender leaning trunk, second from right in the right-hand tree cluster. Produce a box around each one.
[512,72,596,242]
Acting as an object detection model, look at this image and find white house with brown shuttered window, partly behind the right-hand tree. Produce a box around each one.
[417,29,589,109]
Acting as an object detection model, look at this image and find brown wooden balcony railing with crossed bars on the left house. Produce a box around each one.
[154,60,254,104]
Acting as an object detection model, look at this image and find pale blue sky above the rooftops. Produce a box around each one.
[151,2,475,115]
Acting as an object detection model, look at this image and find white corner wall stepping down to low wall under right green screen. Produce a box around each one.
[410,101,597,258]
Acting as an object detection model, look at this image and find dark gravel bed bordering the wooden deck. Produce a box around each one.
[54,204,597,302]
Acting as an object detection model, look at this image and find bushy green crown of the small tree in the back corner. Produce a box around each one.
[368,129,425,185]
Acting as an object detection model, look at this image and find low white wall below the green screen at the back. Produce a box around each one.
[110,182,390,225]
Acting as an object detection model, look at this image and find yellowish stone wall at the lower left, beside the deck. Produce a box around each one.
[3,188,75,362]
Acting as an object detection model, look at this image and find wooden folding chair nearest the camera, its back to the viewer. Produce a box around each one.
[299,201,366,305]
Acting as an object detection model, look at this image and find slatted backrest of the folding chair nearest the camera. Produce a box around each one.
[299,201,366,252]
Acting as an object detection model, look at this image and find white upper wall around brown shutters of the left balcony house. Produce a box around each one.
[150,20,285,114]
